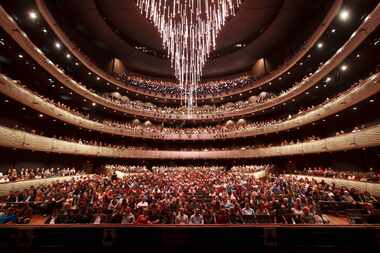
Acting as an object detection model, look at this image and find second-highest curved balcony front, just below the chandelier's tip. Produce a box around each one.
[0,4,380,121]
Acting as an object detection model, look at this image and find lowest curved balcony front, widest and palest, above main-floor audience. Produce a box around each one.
[0,124,380,160]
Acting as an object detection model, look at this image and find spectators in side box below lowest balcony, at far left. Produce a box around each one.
[0,167,83,183]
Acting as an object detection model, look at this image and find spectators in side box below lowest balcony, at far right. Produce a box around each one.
[293,166,380,182]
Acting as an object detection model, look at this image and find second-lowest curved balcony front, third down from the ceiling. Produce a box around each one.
[0,73,380,141]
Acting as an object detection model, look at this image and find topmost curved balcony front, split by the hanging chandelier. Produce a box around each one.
[35,0,343,100]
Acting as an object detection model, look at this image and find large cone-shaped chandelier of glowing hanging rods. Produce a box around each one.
[137,0,243,113]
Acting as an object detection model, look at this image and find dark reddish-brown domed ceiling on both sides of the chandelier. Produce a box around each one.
[46,0,333,78]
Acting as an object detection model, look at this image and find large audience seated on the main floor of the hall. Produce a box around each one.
[0,169,378,225]
